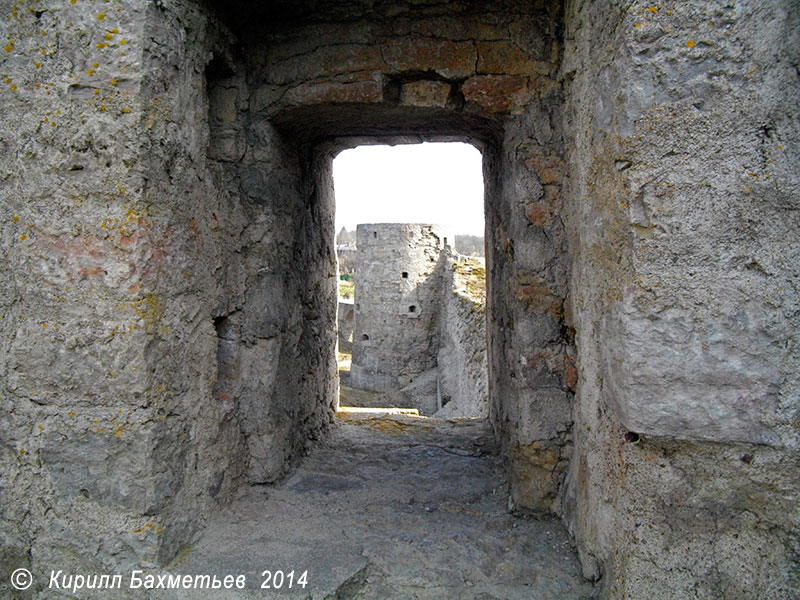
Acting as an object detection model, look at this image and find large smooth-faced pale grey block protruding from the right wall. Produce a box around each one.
[602,287,785,444]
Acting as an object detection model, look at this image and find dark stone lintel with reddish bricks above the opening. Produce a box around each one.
[211,0,560,139]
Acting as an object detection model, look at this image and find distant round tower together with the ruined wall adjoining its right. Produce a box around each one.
[345,223,488,417]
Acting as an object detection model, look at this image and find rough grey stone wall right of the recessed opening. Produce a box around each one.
[562,1,800,599]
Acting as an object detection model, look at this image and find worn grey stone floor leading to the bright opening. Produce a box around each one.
[168,414,593,600]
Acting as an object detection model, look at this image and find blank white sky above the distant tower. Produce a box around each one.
[333,143,484,235]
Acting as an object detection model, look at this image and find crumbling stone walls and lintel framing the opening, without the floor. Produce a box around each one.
[0,0,800,599]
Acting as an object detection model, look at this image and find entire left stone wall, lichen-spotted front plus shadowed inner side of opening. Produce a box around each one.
[0,1,335,585]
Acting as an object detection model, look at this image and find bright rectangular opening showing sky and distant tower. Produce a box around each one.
[333,142,489,418]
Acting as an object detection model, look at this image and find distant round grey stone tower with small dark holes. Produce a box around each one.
[350,223,452,390]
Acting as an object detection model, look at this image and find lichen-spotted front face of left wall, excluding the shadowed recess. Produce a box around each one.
[0,2,223,585]
